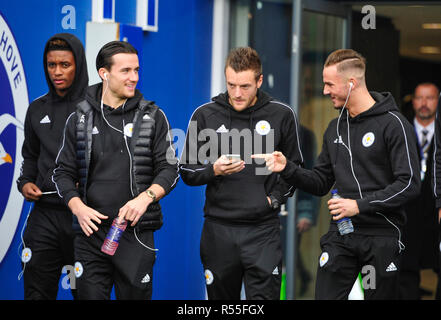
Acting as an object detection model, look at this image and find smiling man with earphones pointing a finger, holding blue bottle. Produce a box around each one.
[253,49,421,299]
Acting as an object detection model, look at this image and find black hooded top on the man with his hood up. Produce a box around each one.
[17,33,89,209]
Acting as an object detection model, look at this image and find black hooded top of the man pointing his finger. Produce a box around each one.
[282,92,421,235]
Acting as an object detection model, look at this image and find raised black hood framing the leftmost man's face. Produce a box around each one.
[43,33,89,101]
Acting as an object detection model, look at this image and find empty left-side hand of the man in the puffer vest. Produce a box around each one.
[68,197,108,236]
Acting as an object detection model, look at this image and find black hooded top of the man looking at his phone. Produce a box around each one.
[180,90,303,224]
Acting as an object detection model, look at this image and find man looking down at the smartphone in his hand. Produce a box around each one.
[180,48,303,300]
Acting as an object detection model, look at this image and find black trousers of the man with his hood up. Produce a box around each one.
[22,206,76,300]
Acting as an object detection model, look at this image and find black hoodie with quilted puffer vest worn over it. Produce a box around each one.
[53,84,179,229]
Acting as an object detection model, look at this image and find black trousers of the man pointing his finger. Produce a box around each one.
[315,232,401,300]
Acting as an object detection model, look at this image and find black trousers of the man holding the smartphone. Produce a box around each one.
[200,219,282,300]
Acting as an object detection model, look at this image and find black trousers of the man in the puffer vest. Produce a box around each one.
[75,226,156,300]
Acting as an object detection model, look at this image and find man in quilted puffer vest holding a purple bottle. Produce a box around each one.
[53,41,179,300]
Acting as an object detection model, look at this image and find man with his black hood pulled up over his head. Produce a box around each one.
[17,33,89,299]
